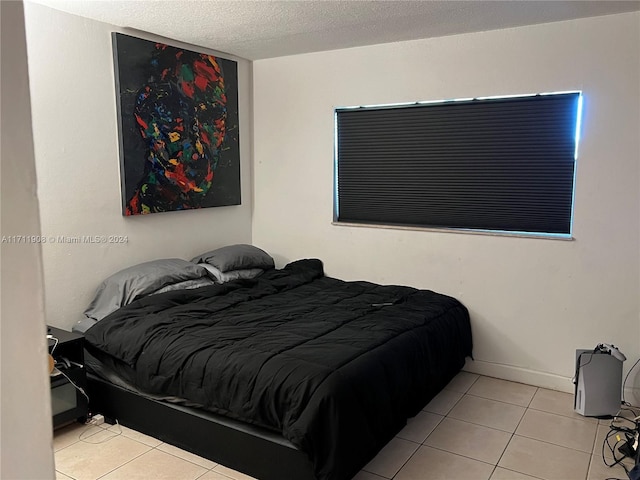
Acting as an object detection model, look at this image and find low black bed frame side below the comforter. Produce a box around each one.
[87,374,315,480]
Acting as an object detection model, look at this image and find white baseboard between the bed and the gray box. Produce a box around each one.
[463,359,574,393]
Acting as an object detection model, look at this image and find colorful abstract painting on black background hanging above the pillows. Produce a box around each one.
[112,33,240,215]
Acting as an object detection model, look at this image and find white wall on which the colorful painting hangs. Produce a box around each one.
[25,3,252,329]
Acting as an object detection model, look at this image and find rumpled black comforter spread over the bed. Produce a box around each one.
[85,260,471,480]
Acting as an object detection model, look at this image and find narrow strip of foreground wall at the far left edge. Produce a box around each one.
[0,2,55,480]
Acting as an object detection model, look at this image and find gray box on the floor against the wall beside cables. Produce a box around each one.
[573,350,622,417]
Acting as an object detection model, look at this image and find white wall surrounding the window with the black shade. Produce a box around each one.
[253,13,640,404]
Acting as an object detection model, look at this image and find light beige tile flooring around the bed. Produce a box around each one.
[54,372,632,480]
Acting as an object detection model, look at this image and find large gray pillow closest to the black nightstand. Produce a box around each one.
[84,258,207,320]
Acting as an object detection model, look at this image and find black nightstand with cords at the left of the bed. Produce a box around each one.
[47,327,88,428]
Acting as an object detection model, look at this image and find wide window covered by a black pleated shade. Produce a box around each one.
[335,92,582,237]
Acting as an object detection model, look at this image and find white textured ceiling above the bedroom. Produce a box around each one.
[26,0,640,60]
